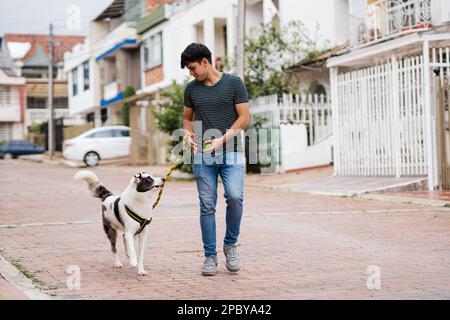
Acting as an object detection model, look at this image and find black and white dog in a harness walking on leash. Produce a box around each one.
[74,170,164,276]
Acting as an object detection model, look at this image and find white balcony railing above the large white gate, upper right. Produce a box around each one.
[350,0,432,48]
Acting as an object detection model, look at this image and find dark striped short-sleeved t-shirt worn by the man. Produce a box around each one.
[184,73,248,152]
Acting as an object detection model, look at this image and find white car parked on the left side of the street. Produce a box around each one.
[63,126,131,166]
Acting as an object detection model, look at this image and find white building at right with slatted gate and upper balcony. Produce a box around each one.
[328,0,450,190]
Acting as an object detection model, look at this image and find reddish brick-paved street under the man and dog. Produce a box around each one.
[0,160,450,299]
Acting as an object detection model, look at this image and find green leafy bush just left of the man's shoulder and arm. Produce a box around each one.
[152,80,192,173]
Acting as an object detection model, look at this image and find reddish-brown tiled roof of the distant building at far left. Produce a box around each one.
[4,33,84,63]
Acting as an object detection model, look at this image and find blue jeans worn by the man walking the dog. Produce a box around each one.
[192,152,244,257]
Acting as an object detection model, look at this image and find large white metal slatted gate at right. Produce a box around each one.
[332,56,427,176]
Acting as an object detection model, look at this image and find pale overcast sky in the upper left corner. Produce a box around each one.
[0,0,113,36]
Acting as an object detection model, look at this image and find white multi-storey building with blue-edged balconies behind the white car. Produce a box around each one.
[64,0,145,127]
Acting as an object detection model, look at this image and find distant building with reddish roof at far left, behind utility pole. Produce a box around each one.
[0,34,84,139]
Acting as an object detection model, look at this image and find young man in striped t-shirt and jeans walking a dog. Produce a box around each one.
[181,43,250,276]
